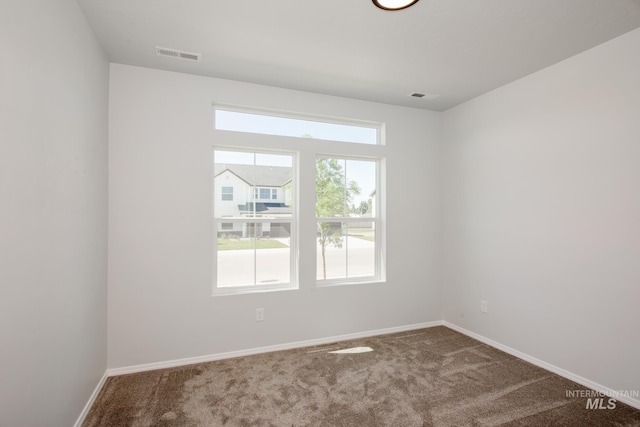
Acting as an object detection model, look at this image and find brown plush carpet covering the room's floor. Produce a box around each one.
[84,327,640,427]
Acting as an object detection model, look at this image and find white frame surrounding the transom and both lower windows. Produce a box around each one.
[213,104,387,296]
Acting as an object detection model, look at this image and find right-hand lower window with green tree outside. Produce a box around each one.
[316,156,381,284]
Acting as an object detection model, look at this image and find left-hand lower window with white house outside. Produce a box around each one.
[213,150,294,293]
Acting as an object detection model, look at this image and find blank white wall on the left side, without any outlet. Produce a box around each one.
[0,0,109,427]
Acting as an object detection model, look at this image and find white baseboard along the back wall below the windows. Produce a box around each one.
[107,320,443,377]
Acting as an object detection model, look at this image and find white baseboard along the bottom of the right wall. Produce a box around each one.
[442,321,640,409]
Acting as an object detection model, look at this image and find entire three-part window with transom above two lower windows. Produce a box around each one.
[213,106,386,295]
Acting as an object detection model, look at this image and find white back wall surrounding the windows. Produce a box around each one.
[108,64,442,368]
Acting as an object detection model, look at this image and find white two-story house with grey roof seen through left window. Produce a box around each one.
[214,163,292,237]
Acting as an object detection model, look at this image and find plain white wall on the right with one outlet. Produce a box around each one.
[443,26,640,390]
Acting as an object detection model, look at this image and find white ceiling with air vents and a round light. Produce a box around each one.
[78,0,640,111]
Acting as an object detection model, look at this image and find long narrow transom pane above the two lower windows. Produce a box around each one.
[215,108,378,145]
